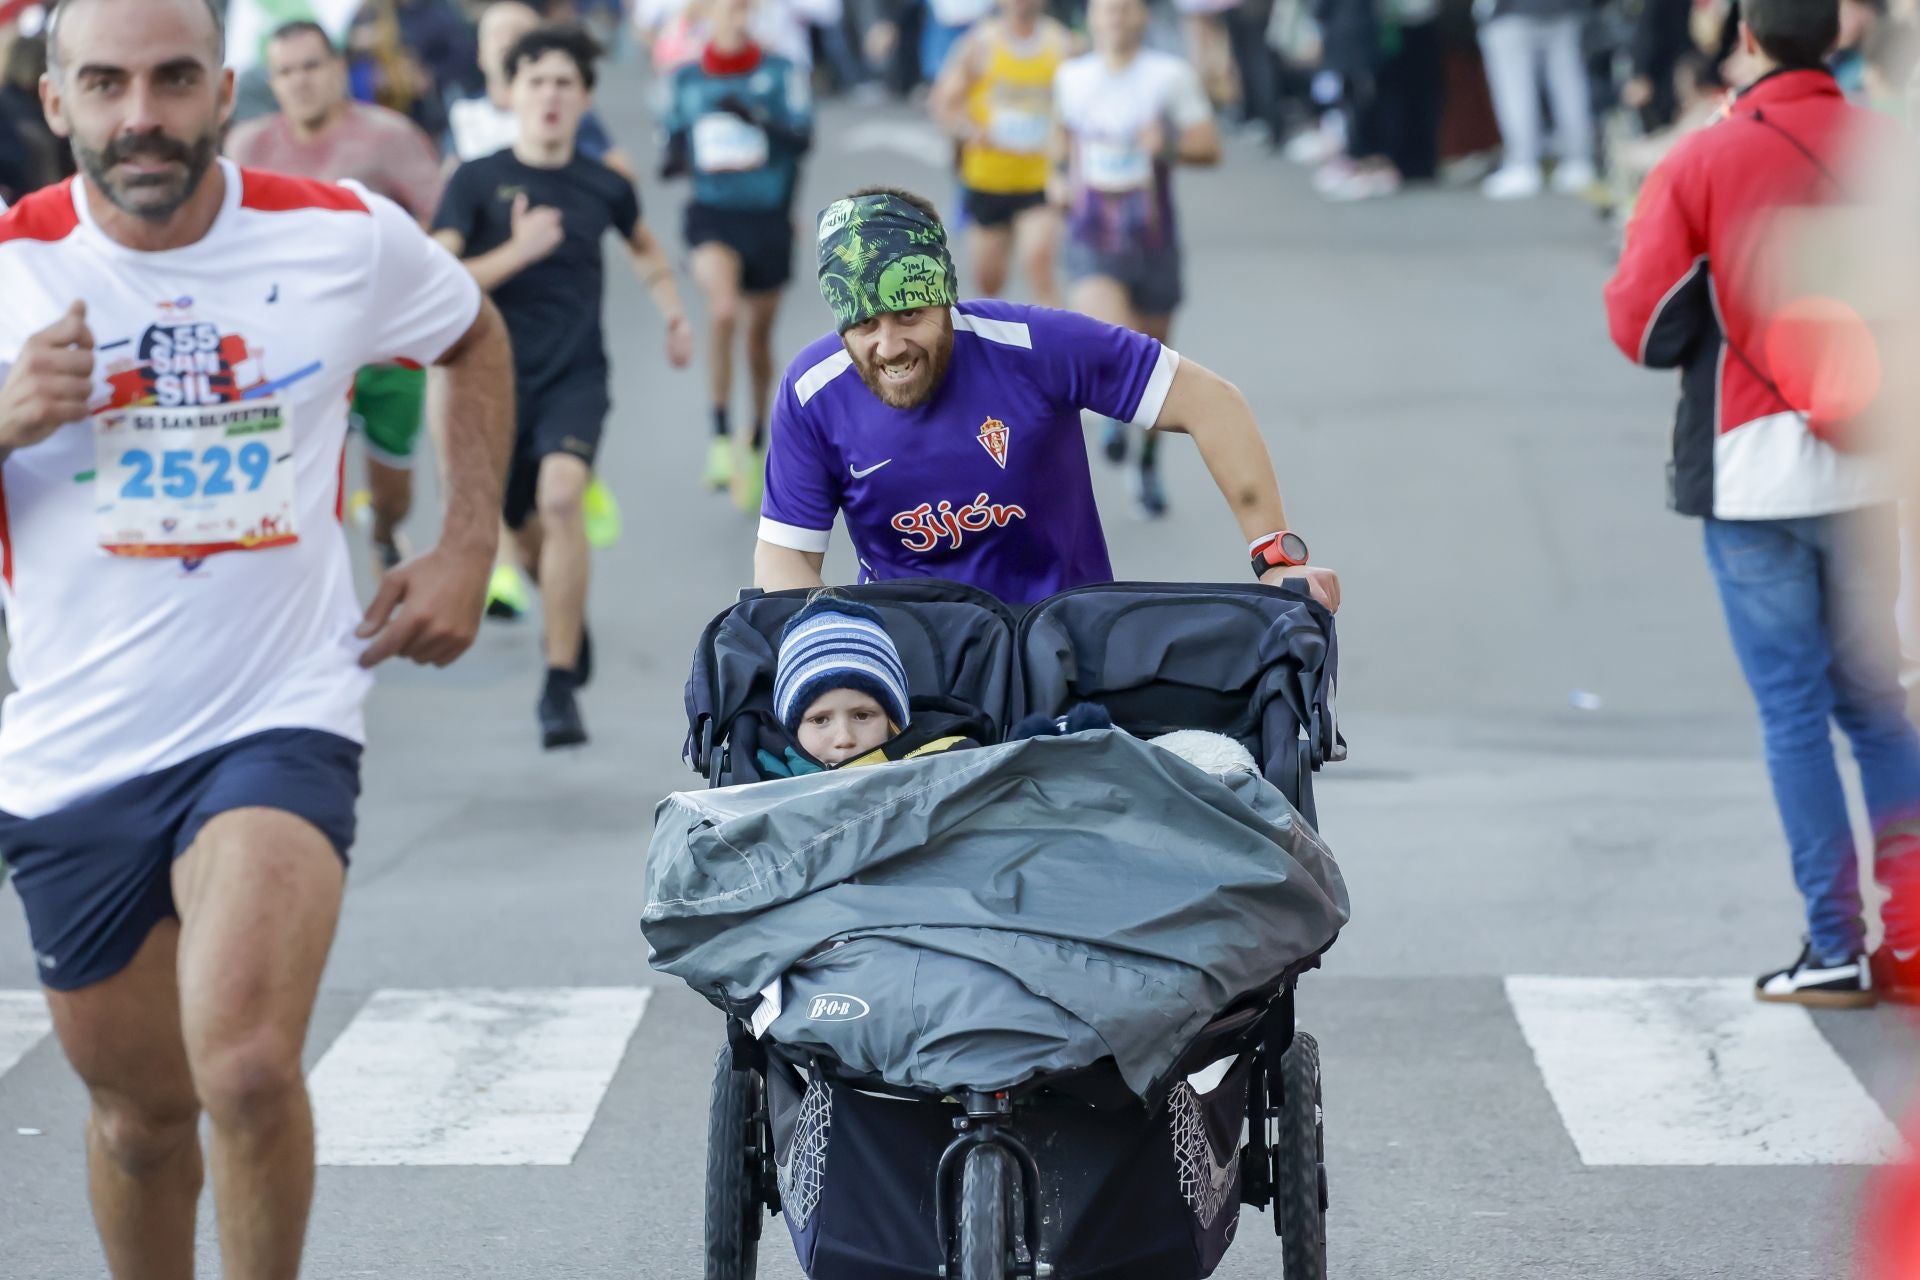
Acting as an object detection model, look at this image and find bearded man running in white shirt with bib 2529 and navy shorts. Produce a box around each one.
[0,0,511,1280]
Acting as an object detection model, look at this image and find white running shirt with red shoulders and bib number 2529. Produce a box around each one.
[0,161,480,818]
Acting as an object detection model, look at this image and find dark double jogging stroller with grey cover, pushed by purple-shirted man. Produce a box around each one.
[643,581,1346,1280]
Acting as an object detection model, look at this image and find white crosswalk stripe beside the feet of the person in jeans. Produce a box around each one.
[1507,977,1901,1165]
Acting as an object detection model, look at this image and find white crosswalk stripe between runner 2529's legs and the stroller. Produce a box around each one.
[307,988,653,1165]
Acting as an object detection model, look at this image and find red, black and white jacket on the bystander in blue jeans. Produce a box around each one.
[1605,71,1889,520]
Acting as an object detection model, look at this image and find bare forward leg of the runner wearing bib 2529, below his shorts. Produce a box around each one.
[173,808,346,1280]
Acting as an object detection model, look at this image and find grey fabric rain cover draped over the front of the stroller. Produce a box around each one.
[641,729,1348,1098]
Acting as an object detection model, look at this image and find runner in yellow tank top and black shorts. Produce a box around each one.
[933,0,1077,307]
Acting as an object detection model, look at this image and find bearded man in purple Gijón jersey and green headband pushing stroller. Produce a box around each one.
[753,188,1340,608]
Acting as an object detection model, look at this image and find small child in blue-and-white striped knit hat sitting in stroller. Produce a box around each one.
[758,591,987,777]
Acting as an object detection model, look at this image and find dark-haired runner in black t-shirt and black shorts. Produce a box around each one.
[434,27,693,748]
